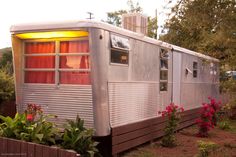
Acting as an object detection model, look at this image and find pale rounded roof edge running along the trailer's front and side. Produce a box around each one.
[10,20,219,62]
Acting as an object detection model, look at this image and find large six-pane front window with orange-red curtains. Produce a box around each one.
[24,38,91,84]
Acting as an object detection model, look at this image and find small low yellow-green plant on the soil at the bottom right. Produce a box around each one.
[198,140,218,157]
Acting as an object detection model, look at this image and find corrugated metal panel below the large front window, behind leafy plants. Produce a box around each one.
[18,85,94,128]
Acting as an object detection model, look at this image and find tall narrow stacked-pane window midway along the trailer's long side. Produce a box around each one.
[160,49,168,91]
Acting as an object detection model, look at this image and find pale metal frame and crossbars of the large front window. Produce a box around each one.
[22,36,91,86]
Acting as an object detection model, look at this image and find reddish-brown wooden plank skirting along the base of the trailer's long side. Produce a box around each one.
[112,108,200,155]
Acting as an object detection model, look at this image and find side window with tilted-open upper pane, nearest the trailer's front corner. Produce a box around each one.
[110,34,130,65]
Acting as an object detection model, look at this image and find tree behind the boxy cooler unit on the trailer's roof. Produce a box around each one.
[106,0,157,38]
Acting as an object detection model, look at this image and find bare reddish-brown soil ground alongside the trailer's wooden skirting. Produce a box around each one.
[122,126,236,157]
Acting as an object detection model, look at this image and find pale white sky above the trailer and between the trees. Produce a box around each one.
[0,0,175,48]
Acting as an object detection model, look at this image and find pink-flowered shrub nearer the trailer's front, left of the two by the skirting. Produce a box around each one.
[159,103,184,147]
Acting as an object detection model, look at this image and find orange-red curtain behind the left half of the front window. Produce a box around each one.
[25,42,55,83]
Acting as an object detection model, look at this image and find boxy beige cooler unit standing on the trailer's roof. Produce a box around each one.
[122,13,148,35]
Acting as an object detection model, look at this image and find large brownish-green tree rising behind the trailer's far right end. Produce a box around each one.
[161,0,236,70]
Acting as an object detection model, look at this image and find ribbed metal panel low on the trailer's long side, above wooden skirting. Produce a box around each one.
[108,82,158,127]
